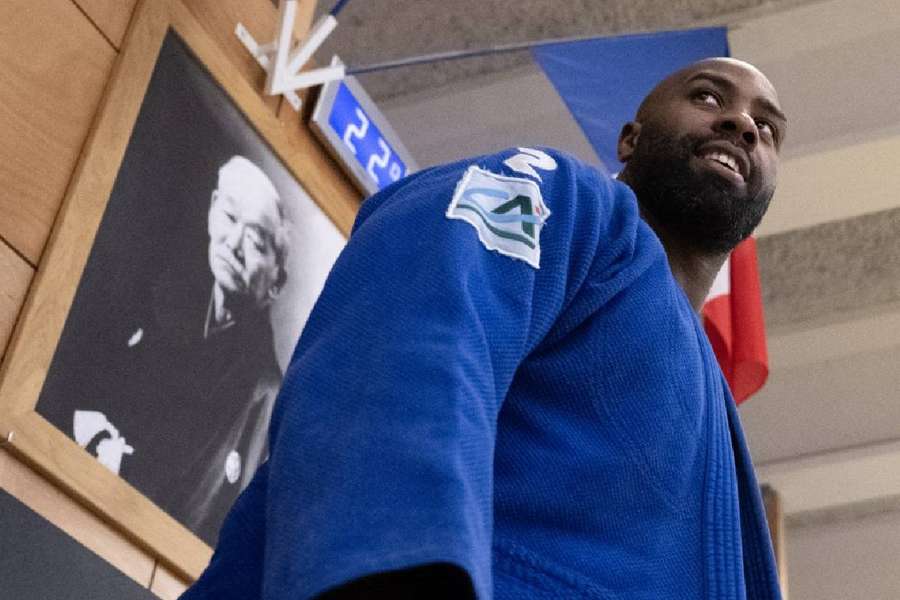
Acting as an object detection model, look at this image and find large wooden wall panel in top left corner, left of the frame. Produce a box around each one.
[0,0,115,265]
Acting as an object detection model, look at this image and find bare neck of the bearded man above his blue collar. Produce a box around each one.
[641,207,728,314]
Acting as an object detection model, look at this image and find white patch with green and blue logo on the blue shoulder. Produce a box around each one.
[447,166,550,269]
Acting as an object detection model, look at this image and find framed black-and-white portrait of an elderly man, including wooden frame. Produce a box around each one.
[0,2,354,576]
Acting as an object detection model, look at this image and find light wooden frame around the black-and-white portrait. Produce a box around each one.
[0,0,360,580]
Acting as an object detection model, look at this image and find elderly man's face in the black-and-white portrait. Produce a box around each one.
[208,168,281,307]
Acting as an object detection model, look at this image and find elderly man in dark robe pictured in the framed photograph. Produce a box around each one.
[39,156,288,542]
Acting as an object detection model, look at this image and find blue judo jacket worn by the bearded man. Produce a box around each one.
[183,149,780,600]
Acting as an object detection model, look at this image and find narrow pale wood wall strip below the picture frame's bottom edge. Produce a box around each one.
[0,449,153,587]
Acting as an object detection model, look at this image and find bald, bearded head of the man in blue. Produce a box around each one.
[619,58,786,253]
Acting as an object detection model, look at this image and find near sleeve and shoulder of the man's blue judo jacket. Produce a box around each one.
[184,150,637,600]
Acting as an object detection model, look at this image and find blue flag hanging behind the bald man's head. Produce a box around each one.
[532,27,728,172]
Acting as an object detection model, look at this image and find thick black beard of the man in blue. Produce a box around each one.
[628,126,775,254]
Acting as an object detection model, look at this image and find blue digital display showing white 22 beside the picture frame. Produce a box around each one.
[312,72,415,193]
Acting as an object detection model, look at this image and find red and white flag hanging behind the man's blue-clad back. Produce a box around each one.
[701,238,769,404]
